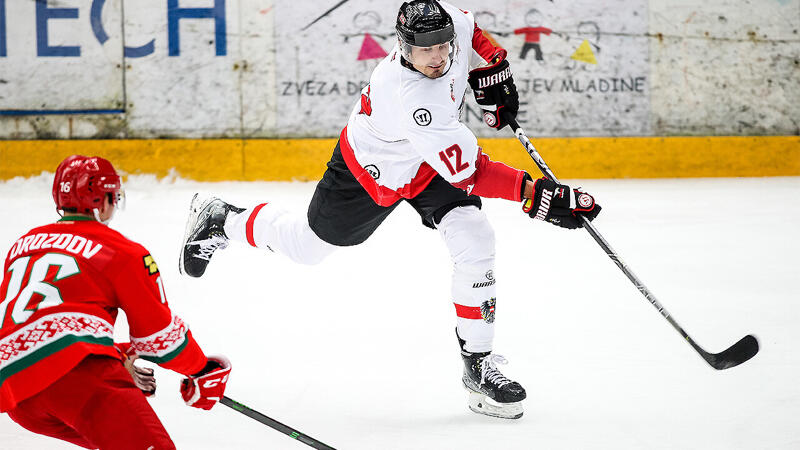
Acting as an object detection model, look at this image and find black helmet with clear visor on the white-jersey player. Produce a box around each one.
[395,0,456,61]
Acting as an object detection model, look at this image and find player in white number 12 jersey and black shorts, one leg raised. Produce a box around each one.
[180,0,600,418]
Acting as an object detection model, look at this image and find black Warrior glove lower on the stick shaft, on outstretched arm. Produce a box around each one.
[522,178,602,229]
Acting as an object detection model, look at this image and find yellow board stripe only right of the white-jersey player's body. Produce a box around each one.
[479,136,800,178]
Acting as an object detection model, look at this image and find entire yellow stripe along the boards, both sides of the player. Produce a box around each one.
[0,136,800,181]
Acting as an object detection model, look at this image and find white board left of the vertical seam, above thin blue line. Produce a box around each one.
[0,0,124,110]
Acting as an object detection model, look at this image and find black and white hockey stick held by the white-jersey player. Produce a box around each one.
[506,116,758,370]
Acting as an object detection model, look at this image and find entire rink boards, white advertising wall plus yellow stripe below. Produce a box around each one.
[0,0,800,181]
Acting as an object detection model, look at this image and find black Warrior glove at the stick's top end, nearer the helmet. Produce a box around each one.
[467,50,519,130]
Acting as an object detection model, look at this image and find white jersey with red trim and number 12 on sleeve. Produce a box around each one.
[340,2,499,206]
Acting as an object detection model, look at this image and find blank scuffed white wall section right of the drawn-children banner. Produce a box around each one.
[650,0,800,135]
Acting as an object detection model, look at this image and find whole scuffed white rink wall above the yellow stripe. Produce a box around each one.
[0,0,800,139]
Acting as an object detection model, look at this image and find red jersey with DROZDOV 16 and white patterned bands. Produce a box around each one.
[0,216,207,412]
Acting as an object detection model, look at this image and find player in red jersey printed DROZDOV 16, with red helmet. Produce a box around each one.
[0,155,231,450]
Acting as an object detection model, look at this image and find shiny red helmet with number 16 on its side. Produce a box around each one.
[53,155,124,214]
